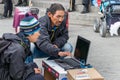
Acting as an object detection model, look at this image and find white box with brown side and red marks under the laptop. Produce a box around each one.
[42,60,67,80]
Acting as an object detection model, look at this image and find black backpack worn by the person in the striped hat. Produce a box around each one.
[0,38,29,80]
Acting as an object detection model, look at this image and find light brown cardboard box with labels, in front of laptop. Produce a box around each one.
[67,68,104,80]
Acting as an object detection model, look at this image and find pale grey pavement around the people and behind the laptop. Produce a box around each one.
[0,18,120,80]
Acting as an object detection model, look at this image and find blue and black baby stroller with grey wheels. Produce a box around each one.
[93,0,120,37]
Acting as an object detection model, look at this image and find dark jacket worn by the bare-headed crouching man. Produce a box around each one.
[36,15,69,57]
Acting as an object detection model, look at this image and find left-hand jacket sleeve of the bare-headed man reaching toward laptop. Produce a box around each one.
[36,16,60,57]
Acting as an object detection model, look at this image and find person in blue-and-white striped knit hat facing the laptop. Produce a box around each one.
[0,16,44,80]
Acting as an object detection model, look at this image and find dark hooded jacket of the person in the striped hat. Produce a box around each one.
[0,33,34,80]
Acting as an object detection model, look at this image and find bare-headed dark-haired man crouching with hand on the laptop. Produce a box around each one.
[34,3,72,59]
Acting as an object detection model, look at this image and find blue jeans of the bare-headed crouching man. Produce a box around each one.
[26,43,73,63]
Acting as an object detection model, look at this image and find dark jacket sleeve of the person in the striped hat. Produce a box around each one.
[5,44,34,80]
